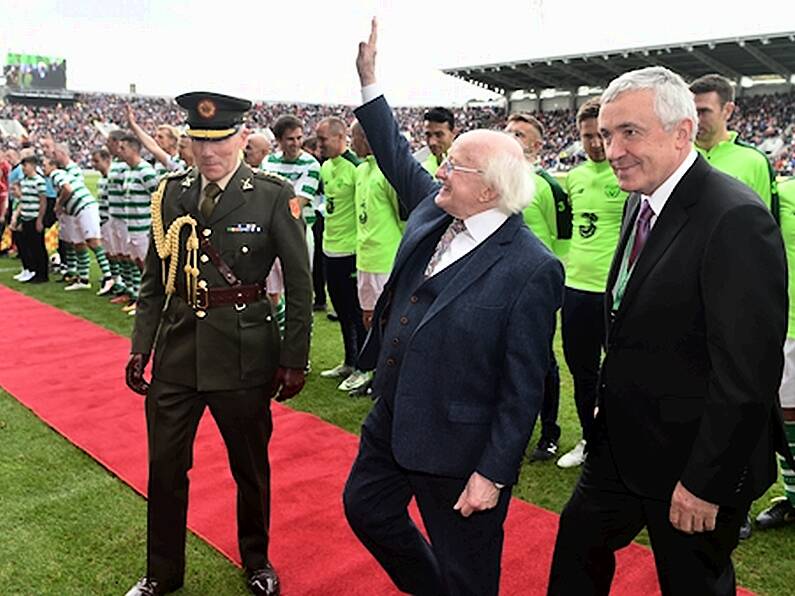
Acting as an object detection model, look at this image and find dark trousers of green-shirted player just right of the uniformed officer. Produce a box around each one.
[324,255,366,366]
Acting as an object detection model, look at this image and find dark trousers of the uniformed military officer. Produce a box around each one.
[146,379,273,590]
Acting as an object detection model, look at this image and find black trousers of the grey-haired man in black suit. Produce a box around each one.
[548,433,750,596]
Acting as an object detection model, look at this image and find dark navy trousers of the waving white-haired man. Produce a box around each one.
[343,398,510,596]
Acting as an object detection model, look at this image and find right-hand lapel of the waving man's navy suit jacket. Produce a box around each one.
[414,215,523,333]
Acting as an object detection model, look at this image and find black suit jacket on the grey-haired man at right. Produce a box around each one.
[596,157,787,504]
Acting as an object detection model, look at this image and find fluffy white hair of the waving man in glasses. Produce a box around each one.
[483,145,535,215]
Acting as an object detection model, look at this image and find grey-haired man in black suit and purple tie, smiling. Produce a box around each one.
[549,67,787,596]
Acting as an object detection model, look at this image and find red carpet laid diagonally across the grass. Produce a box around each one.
[0,285,752,596]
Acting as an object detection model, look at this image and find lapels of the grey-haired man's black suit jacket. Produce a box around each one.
[608,156,709,327]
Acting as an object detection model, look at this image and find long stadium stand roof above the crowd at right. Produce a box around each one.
[443,31,795,93]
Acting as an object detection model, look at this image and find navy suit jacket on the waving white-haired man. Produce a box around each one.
[356,97,563,484]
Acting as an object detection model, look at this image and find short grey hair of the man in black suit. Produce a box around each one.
[601,66,698,141]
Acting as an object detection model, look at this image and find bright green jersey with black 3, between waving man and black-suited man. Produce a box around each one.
[566,159,628,292]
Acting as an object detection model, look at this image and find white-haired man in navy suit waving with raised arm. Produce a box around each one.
[344,21,563,596]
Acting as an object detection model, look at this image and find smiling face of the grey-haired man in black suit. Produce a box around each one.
[599,89,693,195]
